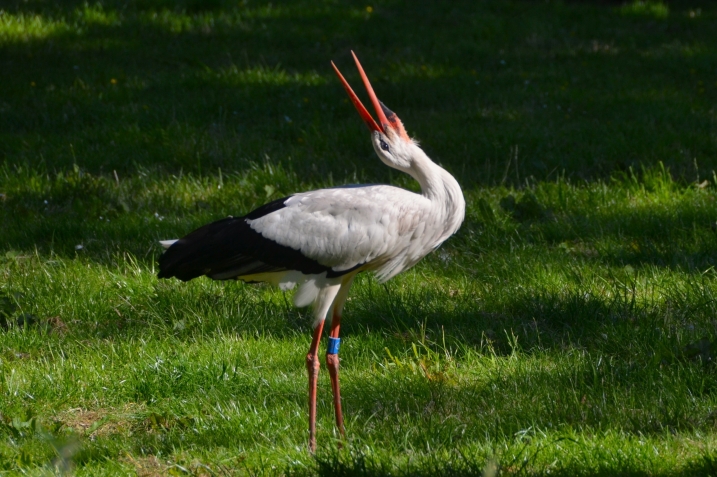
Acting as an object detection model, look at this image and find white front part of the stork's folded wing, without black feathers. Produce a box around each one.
[248,185,430,272]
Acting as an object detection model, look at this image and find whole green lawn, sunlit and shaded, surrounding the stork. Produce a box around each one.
[0,0,717,477]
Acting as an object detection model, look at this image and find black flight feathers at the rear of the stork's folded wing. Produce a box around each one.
[158,197,332,281]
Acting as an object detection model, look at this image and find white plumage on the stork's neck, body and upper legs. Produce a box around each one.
[242,139,465,320]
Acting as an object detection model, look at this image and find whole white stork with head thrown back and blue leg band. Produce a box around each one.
[159,52,465,452]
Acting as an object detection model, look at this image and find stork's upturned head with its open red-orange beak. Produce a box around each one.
[331,51,422,172]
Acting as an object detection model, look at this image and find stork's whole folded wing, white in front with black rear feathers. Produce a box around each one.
[159,186,426,281]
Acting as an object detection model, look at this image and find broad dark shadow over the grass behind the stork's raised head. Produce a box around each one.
[0,0,717,186]
